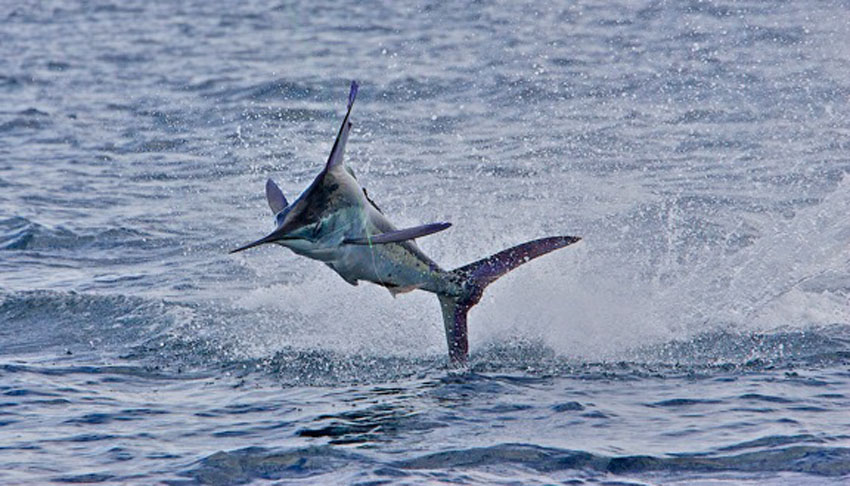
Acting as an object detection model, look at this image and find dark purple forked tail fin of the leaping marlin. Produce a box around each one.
[438,236,581,366]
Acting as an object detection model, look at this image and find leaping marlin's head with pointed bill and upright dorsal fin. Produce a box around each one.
[231,81,362,253]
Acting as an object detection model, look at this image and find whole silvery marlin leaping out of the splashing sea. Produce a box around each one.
[231,81,581,366]
